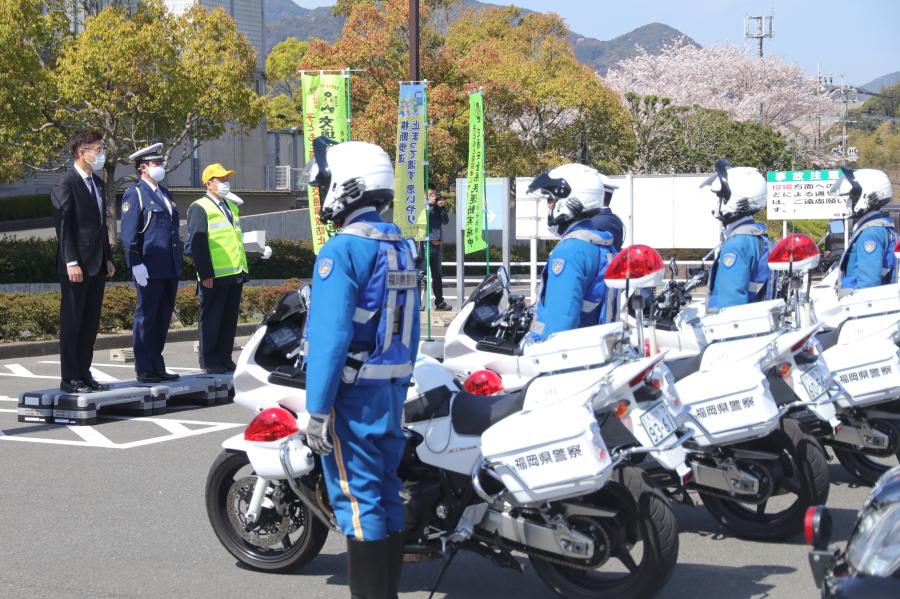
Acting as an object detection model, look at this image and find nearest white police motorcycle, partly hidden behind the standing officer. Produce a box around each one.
[206,284,685,598]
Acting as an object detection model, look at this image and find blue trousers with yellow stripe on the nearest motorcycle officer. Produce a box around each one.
[322,383,406,541]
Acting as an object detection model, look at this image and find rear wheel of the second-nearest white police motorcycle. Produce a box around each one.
[699,418,831,541]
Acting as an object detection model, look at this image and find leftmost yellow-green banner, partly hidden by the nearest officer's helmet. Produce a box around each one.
[300,71,350,254]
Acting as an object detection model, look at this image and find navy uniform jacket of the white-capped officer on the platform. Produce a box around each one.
[122,179,182,279]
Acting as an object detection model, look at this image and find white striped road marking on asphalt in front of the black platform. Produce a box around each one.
[0,408,245,449]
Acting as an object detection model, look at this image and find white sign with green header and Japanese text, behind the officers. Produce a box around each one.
[766,170,847,220]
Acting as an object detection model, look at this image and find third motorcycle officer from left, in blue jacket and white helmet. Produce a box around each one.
[700,160,773,312]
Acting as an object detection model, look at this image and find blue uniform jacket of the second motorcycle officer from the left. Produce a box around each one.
[531,220,615,341]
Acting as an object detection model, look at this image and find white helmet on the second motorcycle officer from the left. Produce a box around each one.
[528,164,615,236]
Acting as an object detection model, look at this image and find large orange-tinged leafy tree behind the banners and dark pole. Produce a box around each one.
[288,0,633,187]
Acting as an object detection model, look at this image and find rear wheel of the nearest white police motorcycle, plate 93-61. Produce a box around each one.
[530,466,678,599]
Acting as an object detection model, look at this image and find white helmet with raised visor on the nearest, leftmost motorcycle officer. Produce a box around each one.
[302,137,394,223]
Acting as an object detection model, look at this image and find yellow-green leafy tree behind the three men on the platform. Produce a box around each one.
[0,0,265,241]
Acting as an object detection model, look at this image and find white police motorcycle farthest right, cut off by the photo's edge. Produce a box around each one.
[779,234,900,485]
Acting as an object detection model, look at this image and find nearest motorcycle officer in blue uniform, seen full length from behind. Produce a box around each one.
[306,137,419,599]
